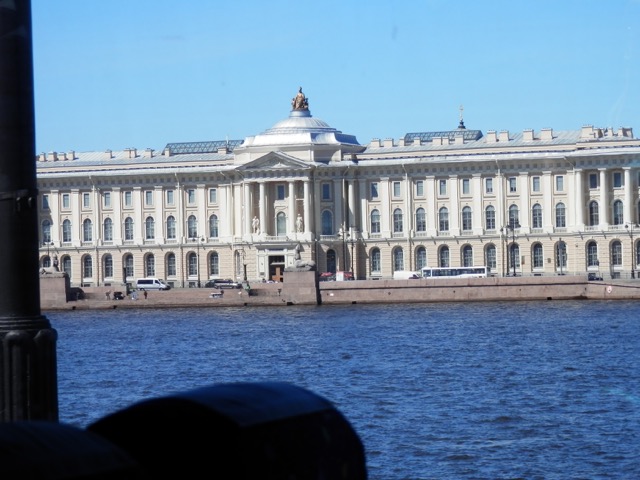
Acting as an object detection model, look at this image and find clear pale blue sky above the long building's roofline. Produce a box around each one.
[32,0,640,153]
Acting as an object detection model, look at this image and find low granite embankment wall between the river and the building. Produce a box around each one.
[41,272,640,311]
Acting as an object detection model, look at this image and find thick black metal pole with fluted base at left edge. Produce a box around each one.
[0,0,58,422]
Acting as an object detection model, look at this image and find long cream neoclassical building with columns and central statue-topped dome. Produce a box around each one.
[37,89,640,287]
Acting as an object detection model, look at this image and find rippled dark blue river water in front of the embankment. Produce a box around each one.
[43,301,640,480]
